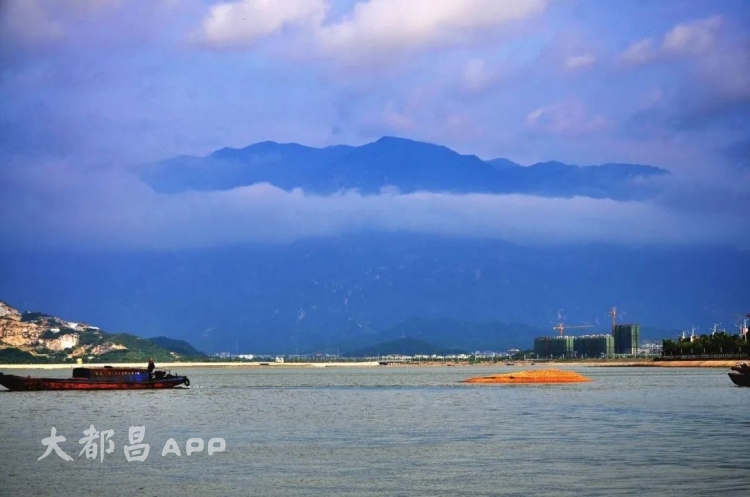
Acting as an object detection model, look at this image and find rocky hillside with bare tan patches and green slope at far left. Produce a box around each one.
[0,301,206,363]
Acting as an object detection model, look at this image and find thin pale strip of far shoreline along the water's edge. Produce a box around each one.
[0,359,743,370]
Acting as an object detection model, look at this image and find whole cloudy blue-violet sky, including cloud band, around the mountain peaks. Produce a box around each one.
[0,0,750,248]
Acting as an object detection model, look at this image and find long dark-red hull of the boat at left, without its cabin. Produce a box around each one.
[0,373,190,392]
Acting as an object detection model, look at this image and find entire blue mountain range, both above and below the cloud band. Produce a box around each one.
[0,137,750,354]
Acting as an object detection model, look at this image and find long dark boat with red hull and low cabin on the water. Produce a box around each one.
[0,366,190,392]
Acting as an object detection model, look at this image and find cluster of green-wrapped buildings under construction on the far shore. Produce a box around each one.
[534,324,641,358]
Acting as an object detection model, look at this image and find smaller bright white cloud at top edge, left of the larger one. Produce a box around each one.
[196,0,327,46]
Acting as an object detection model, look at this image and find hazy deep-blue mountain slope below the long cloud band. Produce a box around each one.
[0,233,750,353]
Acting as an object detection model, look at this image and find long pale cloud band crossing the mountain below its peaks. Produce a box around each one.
[0,160,750,250]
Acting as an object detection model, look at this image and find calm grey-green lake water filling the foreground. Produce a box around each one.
[0,366,750,496]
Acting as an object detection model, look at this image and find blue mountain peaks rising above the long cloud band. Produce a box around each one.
[141,137,669,200]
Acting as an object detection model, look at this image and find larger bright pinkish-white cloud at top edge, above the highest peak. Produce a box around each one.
[320,0,548,57]
